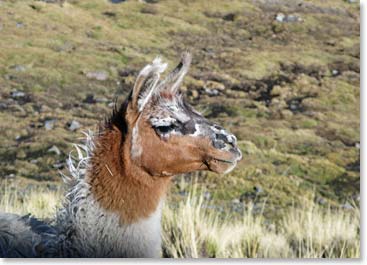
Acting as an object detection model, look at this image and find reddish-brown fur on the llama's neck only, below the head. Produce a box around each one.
[88,125,170,224]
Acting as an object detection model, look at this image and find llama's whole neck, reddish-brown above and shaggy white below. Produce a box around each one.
[57,126,169,257]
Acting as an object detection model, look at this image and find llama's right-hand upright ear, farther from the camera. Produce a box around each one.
[158,52,191,93]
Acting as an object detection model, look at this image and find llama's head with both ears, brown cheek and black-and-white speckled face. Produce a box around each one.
[121,53,242,176]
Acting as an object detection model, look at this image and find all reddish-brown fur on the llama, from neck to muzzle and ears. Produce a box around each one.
[87,55,240,224]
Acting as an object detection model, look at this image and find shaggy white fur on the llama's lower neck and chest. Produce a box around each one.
[57,133,163,257]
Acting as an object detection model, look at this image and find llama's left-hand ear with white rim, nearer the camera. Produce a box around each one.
[130,57,167,112]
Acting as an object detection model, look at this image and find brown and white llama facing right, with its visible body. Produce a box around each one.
[0,52,242,257]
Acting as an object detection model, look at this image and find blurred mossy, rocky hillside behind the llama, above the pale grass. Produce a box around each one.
[0,0,360,255]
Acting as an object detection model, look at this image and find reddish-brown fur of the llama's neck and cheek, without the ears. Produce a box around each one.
[89,106,237,223]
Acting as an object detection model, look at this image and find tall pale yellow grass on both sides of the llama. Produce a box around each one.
[0,180,360,258]
